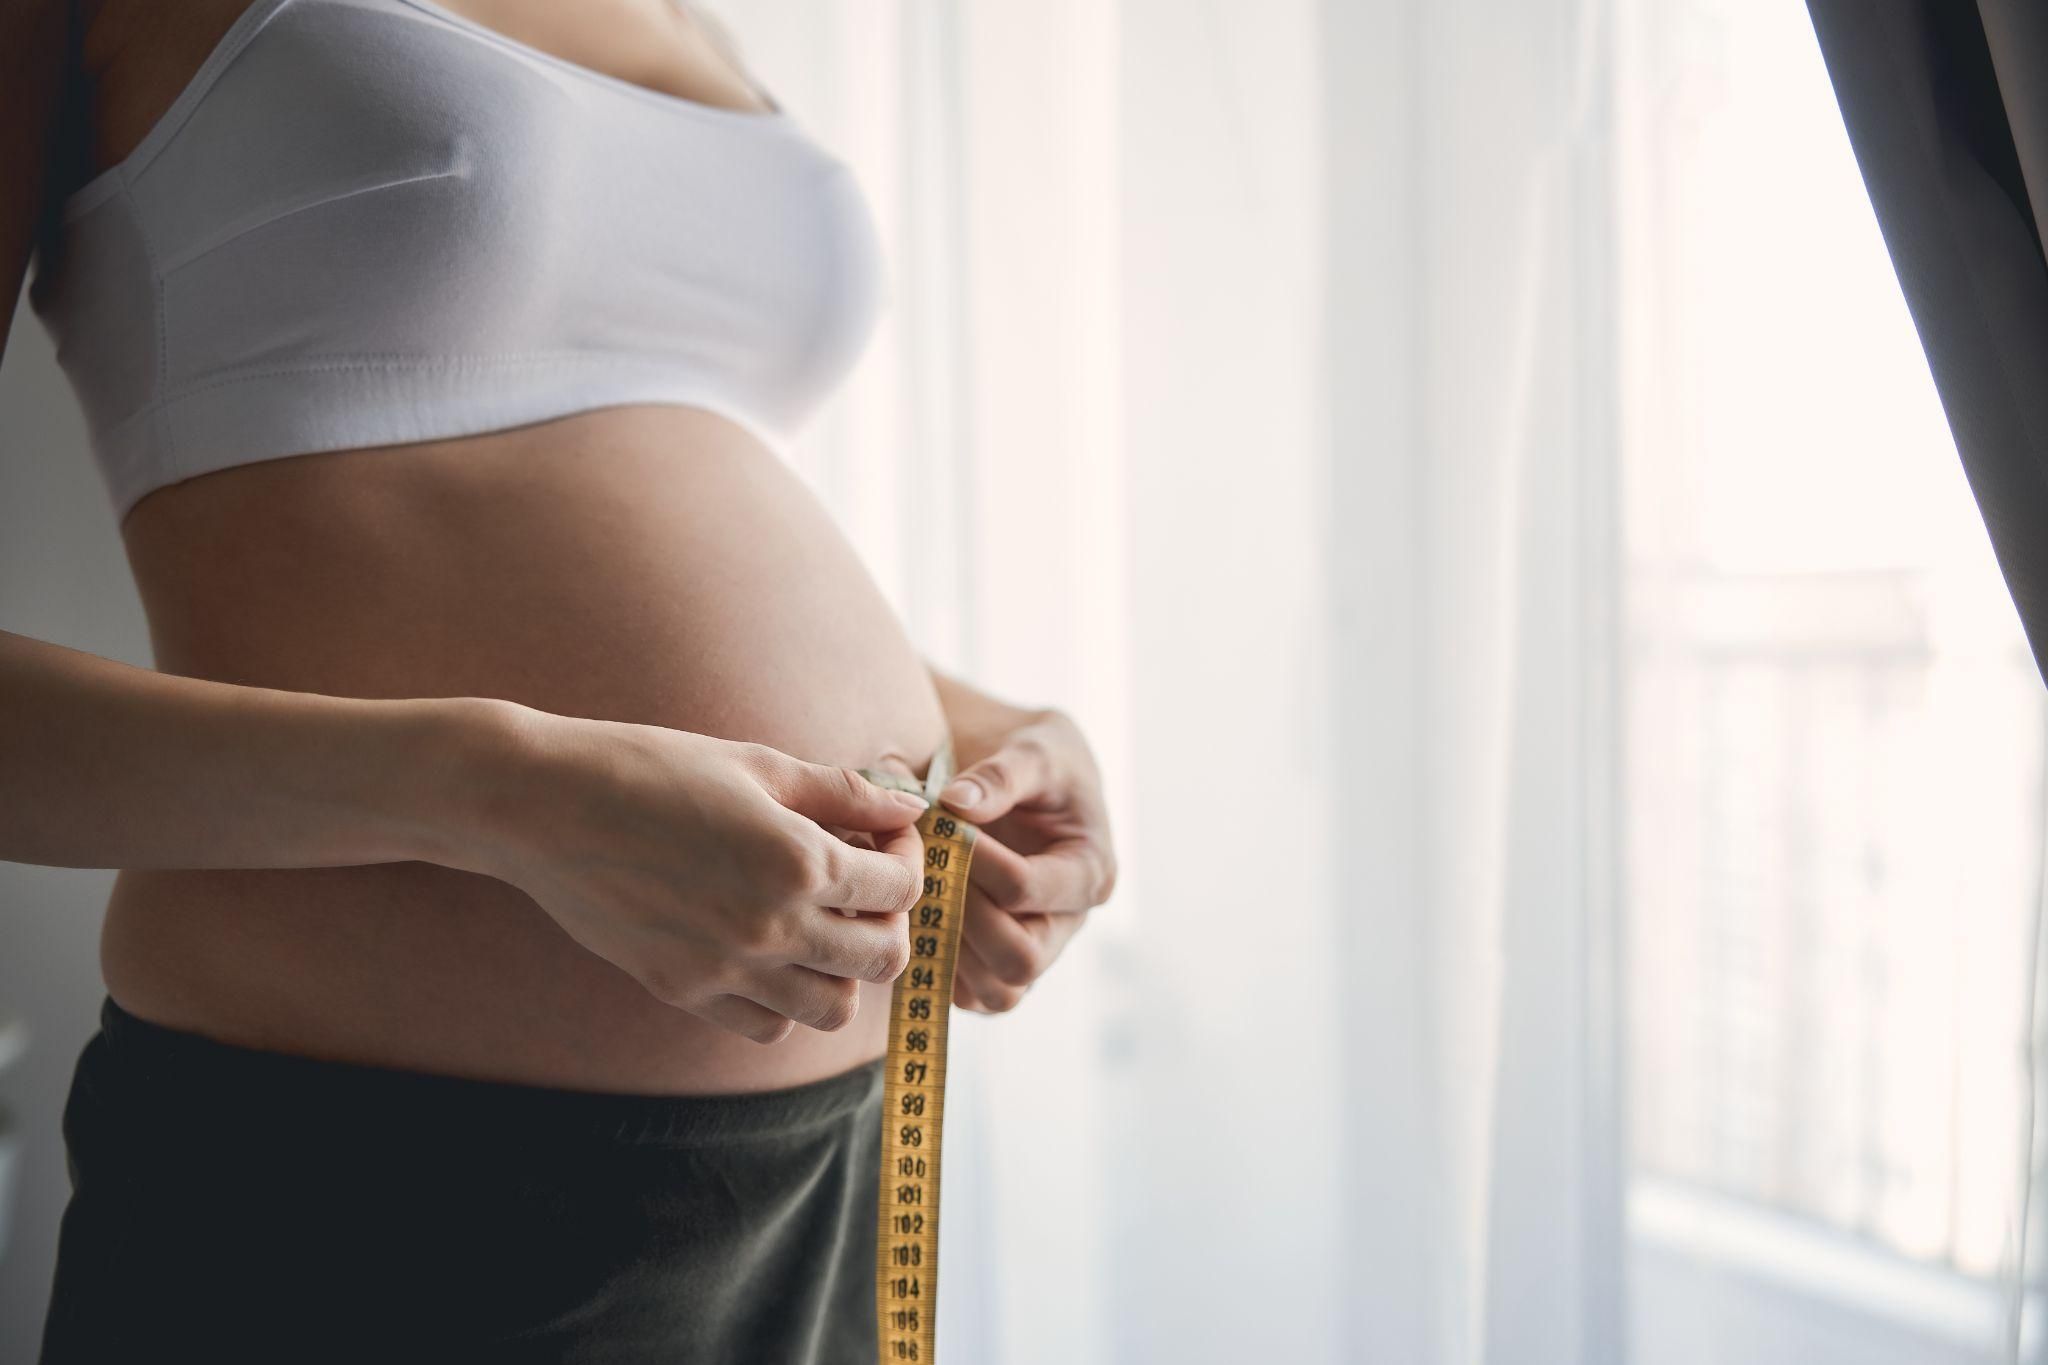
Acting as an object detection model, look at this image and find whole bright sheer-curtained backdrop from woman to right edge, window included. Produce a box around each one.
[725,0,2038,1365]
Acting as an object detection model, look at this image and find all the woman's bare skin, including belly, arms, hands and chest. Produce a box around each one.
[0,0,1114,1093]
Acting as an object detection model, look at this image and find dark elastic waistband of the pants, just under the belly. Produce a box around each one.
[88,997,883,1146]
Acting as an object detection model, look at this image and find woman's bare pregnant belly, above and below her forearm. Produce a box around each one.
[102,407,944,1093]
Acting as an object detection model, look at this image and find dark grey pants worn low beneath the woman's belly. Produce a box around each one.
[43,1001,883,1365]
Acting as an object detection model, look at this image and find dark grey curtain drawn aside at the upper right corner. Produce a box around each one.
[1806,0,2048,677]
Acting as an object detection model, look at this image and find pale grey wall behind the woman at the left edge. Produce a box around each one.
[0,299,150,1361]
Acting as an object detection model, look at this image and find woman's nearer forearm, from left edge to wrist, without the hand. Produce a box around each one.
[0,632,503,868]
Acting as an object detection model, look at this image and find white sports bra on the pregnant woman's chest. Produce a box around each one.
[31,0,883,516]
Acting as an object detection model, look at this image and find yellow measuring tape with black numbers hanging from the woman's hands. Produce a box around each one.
[860,737,975,1365]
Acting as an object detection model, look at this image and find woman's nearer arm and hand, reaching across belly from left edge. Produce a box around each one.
[0,10,924,1042]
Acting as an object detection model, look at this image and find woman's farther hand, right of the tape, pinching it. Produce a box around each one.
[938,710,1116,1015]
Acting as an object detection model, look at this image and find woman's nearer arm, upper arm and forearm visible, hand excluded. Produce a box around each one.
[0,24,477,868]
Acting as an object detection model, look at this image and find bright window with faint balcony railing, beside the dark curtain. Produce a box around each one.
[1618,0,2042,1359]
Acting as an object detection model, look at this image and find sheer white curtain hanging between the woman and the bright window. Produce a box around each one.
[729,0,1616,1361]
